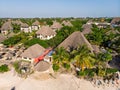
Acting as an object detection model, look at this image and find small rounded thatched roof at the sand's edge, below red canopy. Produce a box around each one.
[35,61,50,72]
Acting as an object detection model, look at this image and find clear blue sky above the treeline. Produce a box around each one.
[0,0,120,17]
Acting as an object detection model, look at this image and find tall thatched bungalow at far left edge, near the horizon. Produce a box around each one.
[1,21,13,35]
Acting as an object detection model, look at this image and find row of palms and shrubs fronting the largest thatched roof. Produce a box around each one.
[53,46,116,76]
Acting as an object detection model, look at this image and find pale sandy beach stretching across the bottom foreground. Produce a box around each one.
[0,70,120,90]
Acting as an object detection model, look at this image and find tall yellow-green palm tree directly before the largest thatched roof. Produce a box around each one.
[71,46,95,71]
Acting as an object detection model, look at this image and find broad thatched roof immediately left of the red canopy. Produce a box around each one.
[21,44,45,58]
